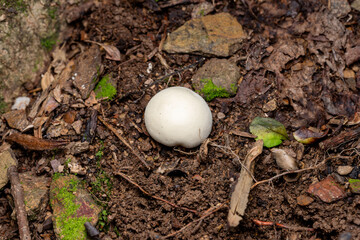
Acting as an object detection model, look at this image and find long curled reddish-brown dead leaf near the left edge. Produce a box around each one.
[6,132,69,151]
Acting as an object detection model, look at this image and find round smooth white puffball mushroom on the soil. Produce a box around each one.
[145,87,212,148]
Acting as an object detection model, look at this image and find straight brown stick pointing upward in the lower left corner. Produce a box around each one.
[7,166,31,240]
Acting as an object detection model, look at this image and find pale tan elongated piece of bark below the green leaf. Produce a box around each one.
[228,140,264,227]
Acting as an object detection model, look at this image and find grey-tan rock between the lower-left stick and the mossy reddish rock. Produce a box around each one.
[19,172,50,220]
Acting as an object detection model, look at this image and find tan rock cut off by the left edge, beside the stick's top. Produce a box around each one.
[0,143,17,189]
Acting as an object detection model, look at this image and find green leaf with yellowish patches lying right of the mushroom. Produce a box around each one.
[250,117,288,148]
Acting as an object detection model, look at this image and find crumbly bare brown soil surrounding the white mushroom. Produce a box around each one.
[0,0,360,239]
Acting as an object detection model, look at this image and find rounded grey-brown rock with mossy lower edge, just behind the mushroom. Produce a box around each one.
[192,58,240,101]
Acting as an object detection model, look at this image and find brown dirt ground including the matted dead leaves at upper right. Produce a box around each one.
[0,0,360,240]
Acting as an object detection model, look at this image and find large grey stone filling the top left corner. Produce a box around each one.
[0,0,65,103]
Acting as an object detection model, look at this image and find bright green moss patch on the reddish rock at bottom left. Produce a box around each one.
[54,179,91,240]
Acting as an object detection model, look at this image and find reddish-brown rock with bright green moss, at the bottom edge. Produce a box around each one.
[50,175,101,239]
